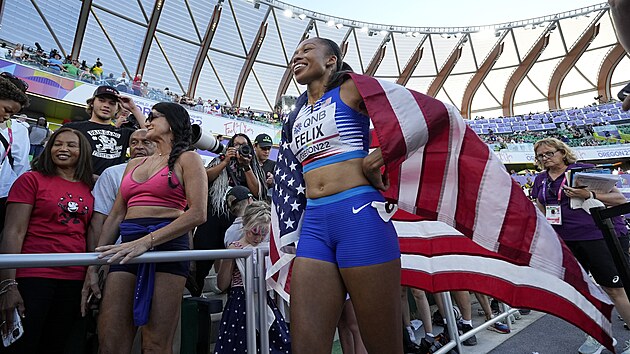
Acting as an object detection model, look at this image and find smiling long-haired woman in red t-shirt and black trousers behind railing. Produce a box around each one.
[0,128,94,354]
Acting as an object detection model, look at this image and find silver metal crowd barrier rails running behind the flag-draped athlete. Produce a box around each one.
[0,247,518,354]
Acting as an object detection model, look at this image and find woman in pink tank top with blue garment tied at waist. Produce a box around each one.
[83,102,208,353]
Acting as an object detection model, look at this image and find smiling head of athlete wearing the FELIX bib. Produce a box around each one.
[291,38,337,85]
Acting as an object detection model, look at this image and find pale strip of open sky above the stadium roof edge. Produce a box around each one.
[283,0,605,27]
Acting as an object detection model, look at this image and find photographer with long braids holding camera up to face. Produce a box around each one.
[188,134,267,296]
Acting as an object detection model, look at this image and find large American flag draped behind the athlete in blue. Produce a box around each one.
[267,74,612,349]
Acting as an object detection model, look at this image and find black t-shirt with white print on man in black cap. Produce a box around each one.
[64,121,133,175]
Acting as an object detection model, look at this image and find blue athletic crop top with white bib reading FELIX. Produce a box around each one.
[290,87,370,173]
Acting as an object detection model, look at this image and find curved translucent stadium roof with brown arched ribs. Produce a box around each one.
[0,0,630,118]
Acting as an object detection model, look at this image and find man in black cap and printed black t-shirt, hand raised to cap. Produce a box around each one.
[65,86,145,175]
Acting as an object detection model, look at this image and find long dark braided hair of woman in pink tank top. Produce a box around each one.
[153,102,193,188]
